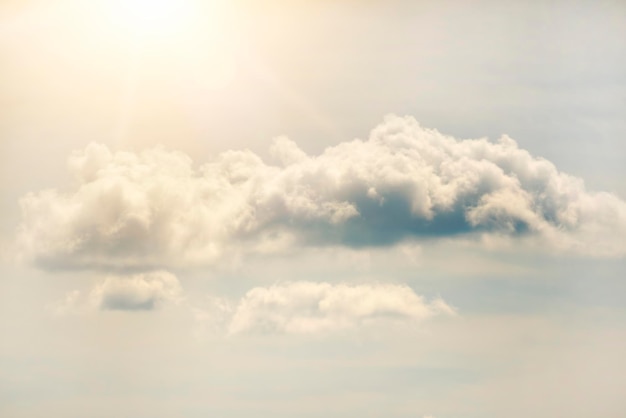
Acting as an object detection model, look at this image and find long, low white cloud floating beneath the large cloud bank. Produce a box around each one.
[197,282,455,335]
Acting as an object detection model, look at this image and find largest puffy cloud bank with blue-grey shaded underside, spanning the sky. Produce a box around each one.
[18,117,626,269]
